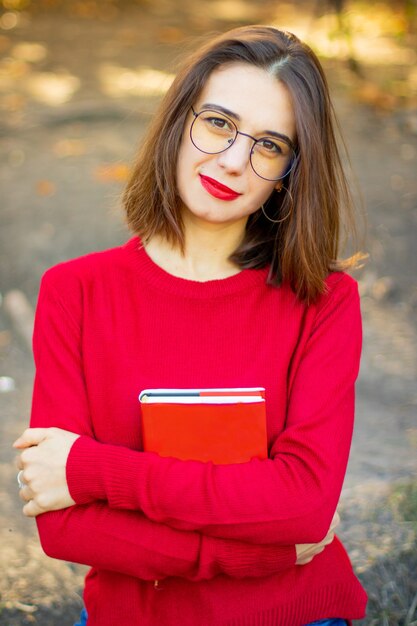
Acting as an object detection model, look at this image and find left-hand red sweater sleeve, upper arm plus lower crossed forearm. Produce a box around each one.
[31,276,296,580]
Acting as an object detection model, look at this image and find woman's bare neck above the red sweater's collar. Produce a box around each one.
[145,217,246,282]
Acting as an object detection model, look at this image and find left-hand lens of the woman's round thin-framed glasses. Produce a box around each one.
[191,110,237,154]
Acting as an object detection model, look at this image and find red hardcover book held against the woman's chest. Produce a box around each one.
[139,387,267,464]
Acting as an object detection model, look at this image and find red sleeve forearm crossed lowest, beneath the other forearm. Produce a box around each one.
[37,502,295,582]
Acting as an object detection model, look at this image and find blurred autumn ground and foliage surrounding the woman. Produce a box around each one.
[0,0,417,626]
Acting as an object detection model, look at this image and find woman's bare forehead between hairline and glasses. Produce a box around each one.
[196,63,296,138]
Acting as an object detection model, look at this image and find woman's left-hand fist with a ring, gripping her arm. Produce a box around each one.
[13,428,79,517]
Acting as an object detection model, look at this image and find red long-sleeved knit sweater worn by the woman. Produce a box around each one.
[31,237,366,626]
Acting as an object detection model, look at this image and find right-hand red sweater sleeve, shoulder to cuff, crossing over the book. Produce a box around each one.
[68,273,362,545]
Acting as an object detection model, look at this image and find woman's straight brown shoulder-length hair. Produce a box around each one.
[123,26,361,302]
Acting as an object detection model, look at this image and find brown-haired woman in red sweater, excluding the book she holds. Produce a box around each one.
[15,26,366,626]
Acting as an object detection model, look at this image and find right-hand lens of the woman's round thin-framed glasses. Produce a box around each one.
[251,137,295,180]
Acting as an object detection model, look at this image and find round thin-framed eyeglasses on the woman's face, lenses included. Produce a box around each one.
[190,107,296,181]
